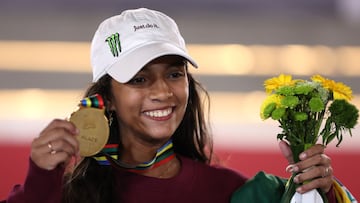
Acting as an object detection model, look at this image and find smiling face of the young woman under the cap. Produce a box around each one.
[111,56,189,142]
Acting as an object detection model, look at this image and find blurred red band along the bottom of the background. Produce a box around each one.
[0,143,360,200]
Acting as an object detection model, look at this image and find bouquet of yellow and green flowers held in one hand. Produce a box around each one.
[260,74,359,202]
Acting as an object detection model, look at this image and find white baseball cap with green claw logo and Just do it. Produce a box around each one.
[91,8,197,83]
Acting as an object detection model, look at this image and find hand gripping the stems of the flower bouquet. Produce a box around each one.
[279,141,333,193]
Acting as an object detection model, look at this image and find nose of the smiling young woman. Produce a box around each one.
[150,79,173,101]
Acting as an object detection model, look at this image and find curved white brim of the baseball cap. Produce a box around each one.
[107,42,198,83]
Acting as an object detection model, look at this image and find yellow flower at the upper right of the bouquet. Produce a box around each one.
[311,75,353,101]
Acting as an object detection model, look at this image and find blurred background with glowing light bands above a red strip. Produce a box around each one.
[0,0,360,199]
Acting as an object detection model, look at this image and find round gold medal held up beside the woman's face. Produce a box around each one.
[70,108,109,156]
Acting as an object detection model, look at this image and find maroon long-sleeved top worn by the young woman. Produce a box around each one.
[0,156,336,203]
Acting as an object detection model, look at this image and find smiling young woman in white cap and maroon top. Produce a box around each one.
[1,8,342,203]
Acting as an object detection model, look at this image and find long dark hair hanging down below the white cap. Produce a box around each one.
[62,70,213,203]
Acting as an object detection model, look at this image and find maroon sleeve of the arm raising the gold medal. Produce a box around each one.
[1,159,64,203]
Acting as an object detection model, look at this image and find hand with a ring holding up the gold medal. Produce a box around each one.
[30,119,79,170]
